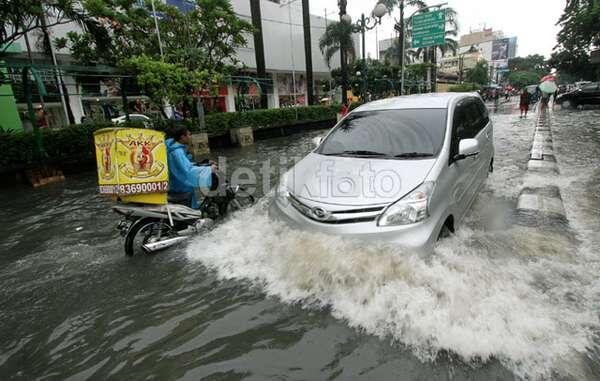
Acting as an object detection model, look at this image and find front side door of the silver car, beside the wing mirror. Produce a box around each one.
[449,98,478,218]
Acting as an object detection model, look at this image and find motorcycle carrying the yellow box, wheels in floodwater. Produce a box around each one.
[113,175,254,256]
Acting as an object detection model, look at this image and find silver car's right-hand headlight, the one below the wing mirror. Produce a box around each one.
[377,181,435,226]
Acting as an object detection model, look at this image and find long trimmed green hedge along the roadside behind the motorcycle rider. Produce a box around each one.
[0,105,339,172]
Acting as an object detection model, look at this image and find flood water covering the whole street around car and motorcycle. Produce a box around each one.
[0,102,600,380]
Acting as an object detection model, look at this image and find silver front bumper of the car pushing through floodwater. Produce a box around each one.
[269,199,441,250]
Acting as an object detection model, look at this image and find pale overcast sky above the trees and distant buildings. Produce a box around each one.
[304,0,565,58]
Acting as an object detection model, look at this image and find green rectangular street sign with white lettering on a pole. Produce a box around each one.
[412,9,446,48]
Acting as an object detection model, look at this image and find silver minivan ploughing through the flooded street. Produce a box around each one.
[272,93,494,248]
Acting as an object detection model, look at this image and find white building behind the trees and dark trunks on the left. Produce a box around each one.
[3,0,359,126]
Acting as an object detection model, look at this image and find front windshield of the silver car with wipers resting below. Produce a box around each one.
[316,109,447,159]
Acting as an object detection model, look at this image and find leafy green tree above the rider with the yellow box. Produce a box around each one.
[59,0,253,73]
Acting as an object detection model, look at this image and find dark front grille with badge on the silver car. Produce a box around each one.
[288,194,385,224]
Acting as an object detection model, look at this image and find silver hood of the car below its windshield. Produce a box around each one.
[282,153,436,206]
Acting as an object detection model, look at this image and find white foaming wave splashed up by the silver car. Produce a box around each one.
[188,194,599,378]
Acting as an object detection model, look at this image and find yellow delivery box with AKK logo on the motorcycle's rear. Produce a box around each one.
[94,128,169,205]
